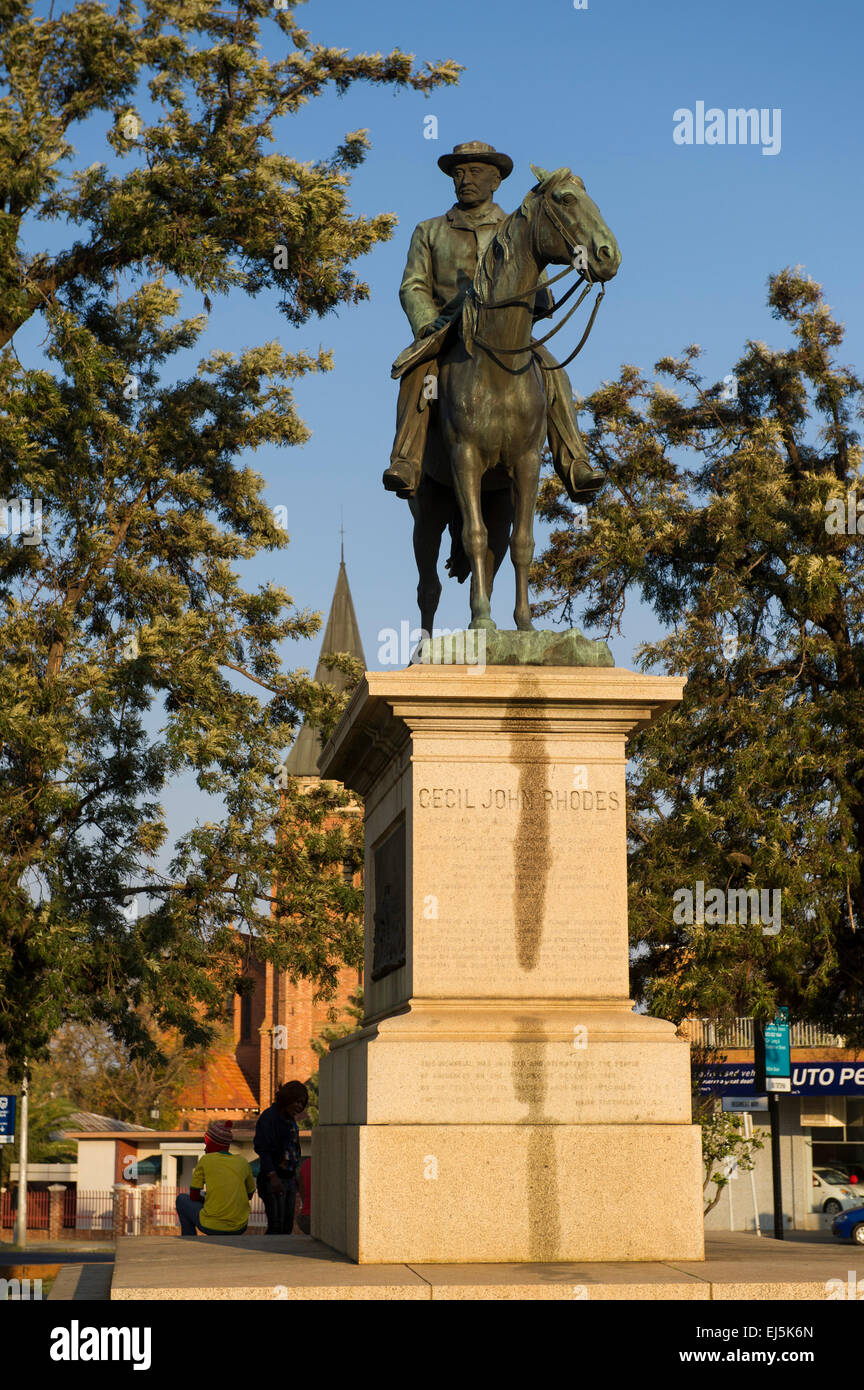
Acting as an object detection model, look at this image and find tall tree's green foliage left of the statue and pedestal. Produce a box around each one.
[0,0,457,1076]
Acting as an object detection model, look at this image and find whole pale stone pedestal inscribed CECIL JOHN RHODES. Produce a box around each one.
[313,666,703,1264]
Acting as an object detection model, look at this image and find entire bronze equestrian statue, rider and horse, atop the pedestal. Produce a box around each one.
[383,140,621,632]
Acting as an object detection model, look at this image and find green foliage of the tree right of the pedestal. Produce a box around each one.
[535,270,864,1041]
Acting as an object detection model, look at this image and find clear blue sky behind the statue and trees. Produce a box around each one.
[18,0,864,856]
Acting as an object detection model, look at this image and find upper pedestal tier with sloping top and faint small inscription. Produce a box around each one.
[319,999,690,1125]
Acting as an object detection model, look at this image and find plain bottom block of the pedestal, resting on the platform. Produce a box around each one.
[313,1125,703,1264]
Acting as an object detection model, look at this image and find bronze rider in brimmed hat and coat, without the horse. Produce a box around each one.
[383,140,603,502]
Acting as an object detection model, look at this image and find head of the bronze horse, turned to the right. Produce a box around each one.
[522,164,621,281]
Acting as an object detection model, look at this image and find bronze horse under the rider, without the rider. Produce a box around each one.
[410,164,621,632]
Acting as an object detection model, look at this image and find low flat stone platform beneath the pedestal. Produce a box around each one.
[104,1232,864,1301]
